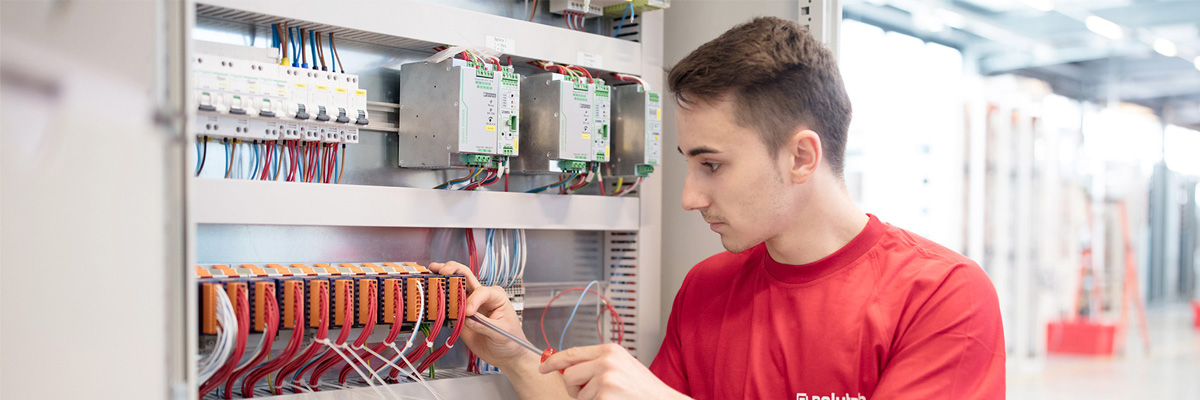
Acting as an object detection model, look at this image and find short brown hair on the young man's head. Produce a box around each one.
[667,17,851,177]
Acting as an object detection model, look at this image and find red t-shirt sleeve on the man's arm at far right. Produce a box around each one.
[871,263,1004,400]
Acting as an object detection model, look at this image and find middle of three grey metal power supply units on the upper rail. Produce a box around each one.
[512,73,596,173]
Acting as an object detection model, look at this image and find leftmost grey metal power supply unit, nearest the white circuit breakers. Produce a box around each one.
[398,59,521,168]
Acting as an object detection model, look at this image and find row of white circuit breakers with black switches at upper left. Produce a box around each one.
[192,54,370,143]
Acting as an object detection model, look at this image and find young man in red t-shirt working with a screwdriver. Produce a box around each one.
[433,18,1004,400]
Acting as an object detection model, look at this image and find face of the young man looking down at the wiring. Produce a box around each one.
[678,97,792,252]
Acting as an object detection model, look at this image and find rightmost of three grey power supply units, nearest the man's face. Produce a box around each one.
[607,84,662,177]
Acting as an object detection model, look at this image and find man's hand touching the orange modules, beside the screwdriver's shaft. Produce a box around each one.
[430,261,538,370]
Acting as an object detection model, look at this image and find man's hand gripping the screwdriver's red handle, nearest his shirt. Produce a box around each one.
[538,344,688,400]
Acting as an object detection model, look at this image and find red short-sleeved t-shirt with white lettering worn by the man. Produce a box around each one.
[650,215,1004,400]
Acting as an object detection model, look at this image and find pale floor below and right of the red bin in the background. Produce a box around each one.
[1008,306,1200,400]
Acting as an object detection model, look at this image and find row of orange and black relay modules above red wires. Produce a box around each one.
[196,263,466,335]
